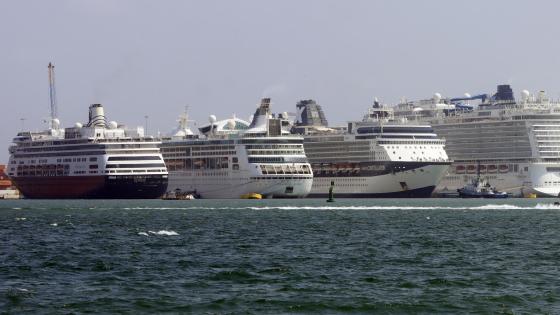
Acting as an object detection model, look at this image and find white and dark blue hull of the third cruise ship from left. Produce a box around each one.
[309,163,449,198]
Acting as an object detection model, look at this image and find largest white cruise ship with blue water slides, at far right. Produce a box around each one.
[395,85,560,197]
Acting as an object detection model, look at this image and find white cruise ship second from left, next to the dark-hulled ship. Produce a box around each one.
[161,98,313,199]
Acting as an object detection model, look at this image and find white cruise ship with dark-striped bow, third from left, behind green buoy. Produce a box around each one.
[292,100,450,198]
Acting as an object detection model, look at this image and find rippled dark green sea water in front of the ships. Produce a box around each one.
[0,199,560,314]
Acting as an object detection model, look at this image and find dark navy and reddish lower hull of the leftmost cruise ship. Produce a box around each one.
[12,175,167,199]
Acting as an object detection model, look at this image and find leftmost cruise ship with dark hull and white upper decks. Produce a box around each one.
[7,104,168,199]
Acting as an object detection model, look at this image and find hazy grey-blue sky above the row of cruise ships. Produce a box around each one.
[0,0,560,162]
